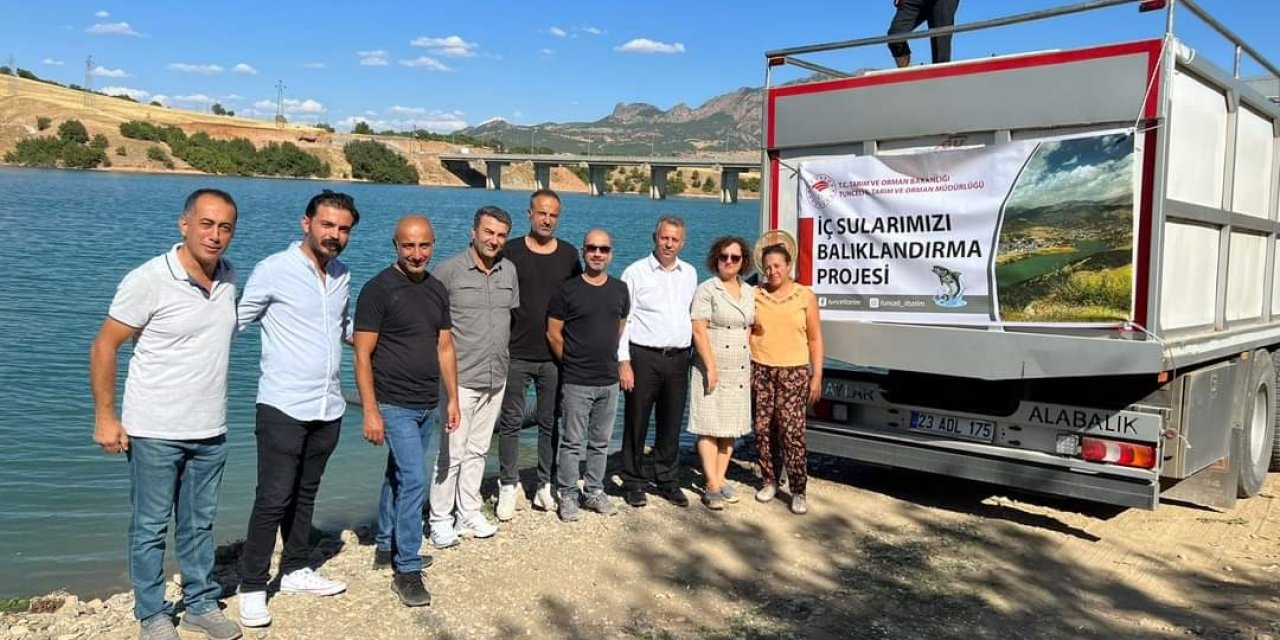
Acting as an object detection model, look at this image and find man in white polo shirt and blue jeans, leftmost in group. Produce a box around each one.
[90,189,241,640]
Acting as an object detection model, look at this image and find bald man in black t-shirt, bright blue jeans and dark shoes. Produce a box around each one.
[356,214,458,607]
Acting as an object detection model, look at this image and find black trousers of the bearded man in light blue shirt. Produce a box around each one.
[241,403,342,591]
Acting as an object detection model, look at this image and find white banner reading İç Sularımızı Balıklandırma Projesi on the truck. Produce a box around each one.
[797,132,1135,324]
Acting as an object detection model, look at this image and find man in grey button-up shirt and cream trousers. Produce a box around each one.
[430,206,520,548]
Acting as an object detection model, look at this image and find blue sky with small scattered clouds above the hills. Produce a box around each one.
[0,0,1280,133]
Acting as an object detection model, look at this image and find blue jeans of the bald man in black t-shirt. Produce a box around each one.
[374,403,438,573]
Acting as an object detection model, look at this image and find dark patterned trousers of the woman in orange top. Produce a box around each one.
[751,362,809,495]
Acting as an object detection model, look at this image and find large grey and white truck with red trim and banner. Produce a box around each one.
[758,0,1280,509]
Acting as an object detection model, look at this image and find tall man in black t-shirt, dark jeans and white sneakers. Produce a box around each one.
[495,189,582,521]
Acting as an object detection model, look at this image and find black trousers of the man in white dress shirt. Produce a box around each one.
[622,343,690,490]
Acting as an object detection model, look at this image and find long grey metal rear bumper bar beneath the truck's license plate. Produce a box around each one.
[806,421,1160,509]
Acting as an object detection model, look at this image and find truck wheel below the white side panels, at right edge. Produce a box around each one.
[1236,349,1276,498]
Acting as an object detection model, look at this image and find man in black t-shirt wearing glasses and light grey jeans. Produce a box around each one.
[547,229,631,522]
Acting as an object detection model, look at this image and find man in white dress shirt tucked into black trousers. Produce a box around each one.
[618,215,698,507]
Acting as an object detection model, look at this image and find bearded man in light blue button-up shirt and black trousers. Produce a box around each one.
[238,189,360,627]
